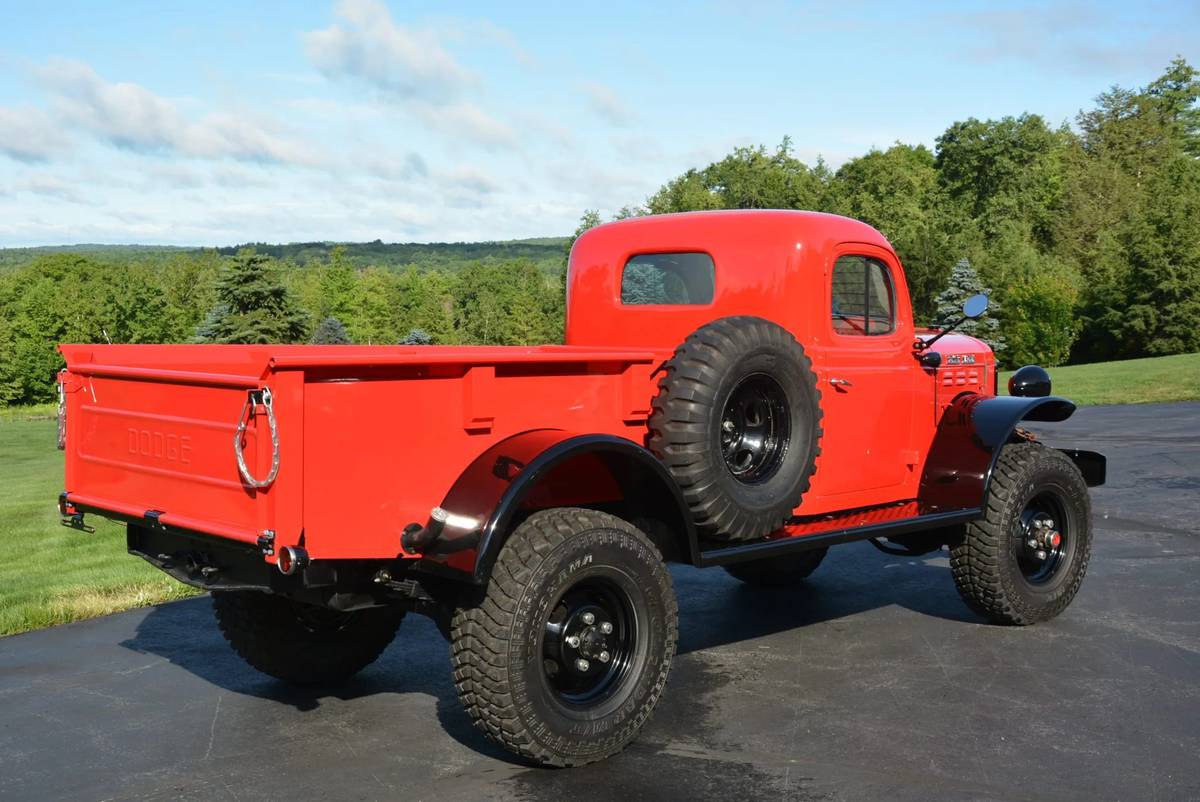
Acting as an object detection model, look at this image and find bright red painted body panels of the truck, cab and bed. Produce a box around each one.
[61,211,995,559]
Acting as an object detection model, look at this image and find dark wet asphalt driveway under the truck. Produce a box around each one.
[0,403,1200,802]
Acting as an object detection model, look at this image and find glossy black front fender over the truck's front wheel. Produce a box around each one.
[918,393,1105,511]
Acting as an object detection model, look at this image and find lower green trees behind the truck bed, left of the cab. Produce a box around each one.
[0,245,563,405]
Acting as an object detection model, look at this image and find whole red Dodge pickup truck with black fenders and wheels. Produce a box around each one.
[60,211,1105,766]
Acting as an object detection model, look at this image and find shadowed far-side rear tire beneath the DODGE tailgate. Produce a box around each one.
[212,591,404,686]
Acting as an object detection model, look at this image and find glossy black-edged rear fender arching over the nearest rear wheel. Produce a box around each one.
[418,429,697,585]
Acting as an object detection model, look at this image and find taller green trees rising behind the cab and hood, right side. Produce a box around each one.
[604,59,1200,366]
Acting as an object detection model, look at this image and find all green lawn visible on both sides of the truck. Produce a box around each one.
[0,354,1200,635]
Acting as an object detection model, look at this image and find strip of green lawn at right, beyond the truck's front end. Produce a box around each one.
[1000,354,1200,406]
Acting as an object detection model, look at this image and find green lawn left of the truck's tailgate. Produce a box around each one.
[0,415,194,635]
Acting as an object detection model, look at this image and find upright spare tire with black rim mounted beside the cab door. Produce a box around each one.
[649,317,821,540]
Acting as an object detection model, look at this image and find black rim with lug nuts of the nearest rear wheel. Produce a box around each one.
[542,577,637,707]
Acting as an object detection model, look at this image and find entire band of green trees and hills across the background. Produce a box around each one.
[0,59,1200,405]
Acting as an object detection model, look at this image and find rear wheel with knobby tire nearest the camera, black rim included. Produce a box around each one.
[450,508,678,766]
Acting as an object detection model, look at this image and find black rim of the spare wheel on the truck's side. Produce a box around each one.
[721,373,791,484]
